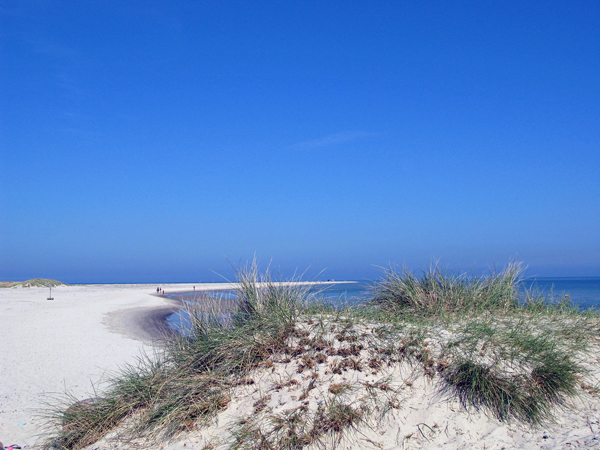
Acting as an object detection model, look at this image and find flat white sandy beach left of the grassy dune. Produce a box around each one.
[0,284,230,447]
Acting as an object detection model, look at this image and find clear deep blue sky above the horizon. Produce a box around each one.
[0,0,600,283]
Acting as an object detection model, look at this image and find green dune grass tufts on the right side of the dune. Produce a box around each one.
[371,264,599,425]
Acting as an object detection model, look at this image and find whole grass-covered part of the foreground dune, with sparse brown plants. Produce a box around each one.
[46,264,600,449]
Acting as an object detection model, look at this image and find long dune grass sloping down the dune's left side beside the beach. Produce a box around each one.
[41,265,308,448]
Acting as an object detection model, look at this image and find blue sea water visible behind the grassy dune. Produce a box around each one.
[167,277,600,332]
